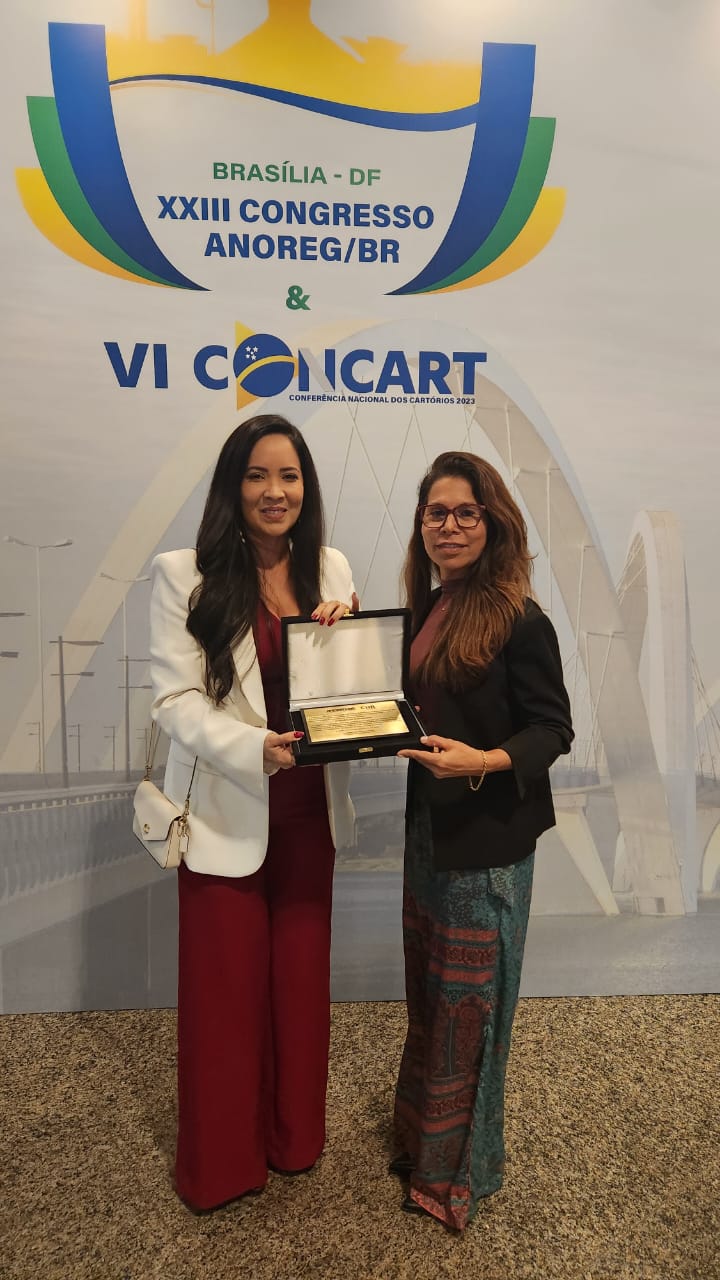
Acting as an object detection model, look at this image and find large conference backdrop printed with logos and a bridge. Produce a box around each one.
[0,0,720,1012]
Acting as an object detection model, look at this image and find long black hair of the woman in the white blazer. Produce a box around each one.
[187,413,324,703]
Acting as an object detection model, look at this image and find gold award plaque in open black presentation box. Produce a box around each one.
[282,609,425,764]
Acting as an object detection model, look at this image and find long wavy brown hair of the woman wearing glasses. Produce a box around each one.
[404,453,532,689]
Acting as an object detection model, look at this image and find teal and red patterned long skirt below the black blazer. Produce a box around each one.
[395,786,534,1229]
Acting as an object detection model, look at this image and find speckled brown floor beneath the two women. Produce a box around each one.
[0,996,720,1280]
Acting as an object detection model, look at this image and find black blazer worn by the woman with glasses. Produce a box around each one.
[407,599,573,870]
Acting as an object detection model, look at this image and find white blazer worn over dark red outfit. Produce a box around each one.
[150,547,355,876]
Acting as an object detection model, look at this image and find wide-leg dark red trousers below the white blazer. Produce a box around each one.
[176,805,334,1208]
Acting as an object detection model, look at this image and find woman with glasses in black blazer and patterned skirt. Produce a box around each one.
[391,453,573,1229]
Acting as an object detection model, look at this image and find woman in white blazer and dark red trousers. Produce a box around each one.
[150,415,357,1210]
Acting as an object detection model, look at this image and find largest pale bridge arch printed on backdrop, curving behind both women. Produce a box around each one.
[4,320,691,914]
